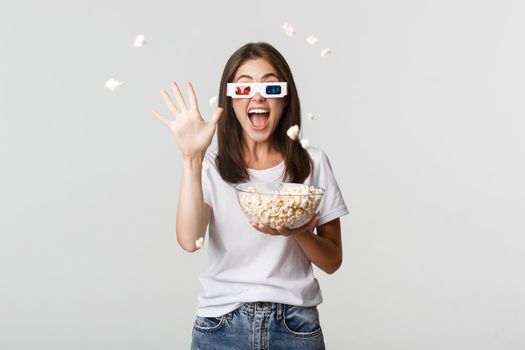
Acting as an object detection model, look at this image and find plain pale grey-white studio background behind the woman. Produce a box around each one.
[0,0,525,350]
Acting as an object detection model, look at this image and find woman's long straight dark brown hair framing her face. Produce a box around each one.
[215,42,313,183]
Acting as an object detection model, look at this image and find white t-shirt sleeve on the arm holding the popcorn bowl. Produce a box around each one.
[317,151,349,226]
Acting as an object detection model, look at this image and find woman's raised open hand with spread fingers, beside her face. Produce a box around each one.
[152,82,223,158]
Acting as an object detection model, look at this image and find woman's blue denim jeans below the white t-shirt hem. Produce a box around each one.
[191,302,325,350]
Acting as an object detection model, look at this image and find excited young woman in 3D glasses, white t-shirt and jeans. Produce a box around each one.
[153,42,348,350]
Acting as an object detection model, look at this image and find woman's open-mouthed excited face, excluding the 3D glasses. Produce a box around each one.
[232,58,287,142]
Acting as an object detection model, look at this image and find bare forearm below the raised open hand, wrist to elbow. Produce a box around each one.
[176,156,211,252]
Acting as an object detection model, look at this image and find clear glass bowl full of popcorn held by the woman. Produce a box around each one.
[234,182,325,229]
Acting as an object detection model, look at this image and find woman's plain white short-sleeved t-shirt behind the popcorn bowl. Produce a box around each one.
[197,147,348,317]
